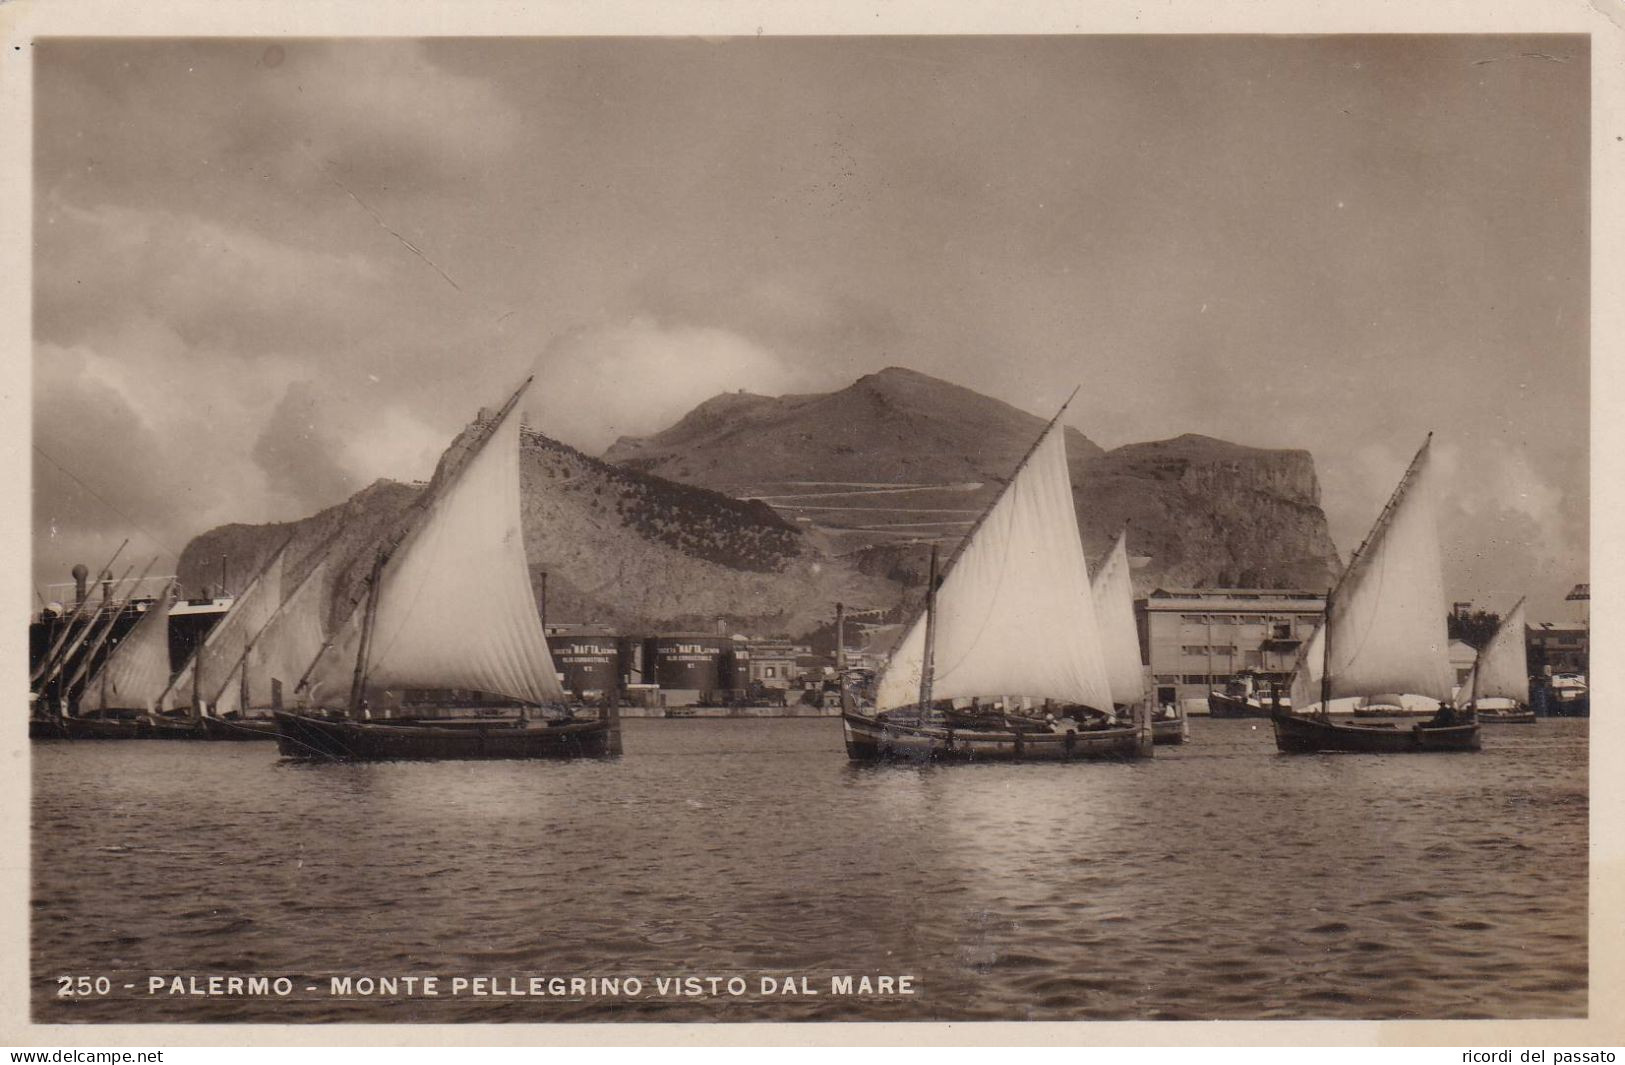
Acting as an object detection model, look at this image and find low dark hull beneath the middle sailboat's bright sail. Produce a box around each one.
[842,712,1152,763]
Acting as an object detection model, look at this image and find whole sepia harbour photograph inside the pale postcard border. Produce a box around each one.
[8,8,1612,1037]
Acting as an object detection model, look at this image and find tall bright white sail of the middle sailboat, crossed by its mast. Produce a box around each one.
[876,421,1112,711]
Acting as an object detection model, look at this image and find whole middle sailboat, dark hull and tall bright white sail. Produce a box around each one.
[842,400,1152,761]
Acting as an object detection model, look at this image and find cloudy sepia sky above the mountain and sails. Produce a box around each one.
[33,36,1591,619]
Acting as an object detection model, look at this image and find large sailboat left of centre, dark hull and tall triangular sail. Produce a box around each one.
[275,379,621,759]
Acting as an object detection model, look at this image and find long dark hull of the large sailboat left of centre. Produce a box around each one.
[276,712,621,761]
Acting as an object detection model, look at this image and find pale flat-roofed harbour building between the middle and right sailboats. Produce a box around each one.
[1134,589,1326,702]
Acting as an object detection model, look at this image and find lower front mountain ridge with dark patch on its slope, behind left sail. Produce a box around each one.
[179,431,895,634]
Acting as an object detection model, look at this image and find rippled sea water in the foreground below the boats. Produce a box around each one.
[31,719,1588,1023]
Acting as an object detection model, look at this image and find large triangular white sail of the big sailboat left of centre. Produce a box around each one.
[355,399,566,704]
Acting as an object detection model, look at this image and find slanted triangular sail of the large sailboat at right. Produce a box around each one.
[1292,444,1454,707]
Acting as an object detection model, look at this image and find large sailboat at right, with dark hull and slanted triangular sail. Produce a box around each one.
[1271,433,1479,753]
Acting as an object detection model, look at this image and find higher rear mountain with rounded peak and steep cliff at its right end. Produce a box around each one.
[605,367,1337,592]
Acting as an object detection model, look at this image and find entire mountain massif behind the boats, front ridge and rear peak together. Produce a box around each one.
[179,369,1337,653]
